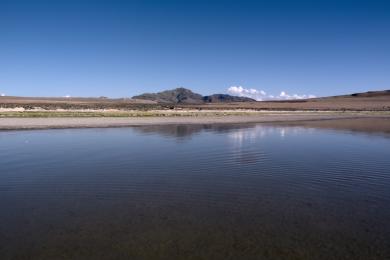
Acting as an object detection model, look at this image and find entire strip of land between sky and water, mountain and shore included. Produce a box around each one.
[0,89,390,130]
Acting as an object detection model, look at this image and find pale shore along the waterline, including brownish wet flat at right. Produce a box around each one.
[0,113,390,132]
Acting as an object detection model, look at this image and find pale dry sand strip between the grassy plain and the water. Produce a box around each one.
[0,113,390,130]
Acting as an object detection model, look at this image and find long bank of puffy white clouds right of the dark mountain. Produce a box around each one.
[227,86,316,101]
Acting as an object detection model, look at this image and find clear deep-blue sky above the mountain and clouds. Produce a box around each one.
[0,0,390,97]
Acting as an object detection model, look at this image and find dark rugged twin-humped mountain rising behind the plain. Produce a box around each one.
[132,88,255,104]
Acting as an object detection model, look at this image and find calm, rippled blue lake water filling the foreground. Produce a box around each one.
[0,125,390,259]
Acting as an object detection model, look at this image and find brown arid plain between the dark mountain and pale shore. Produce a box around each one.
[0,90,390,112]
